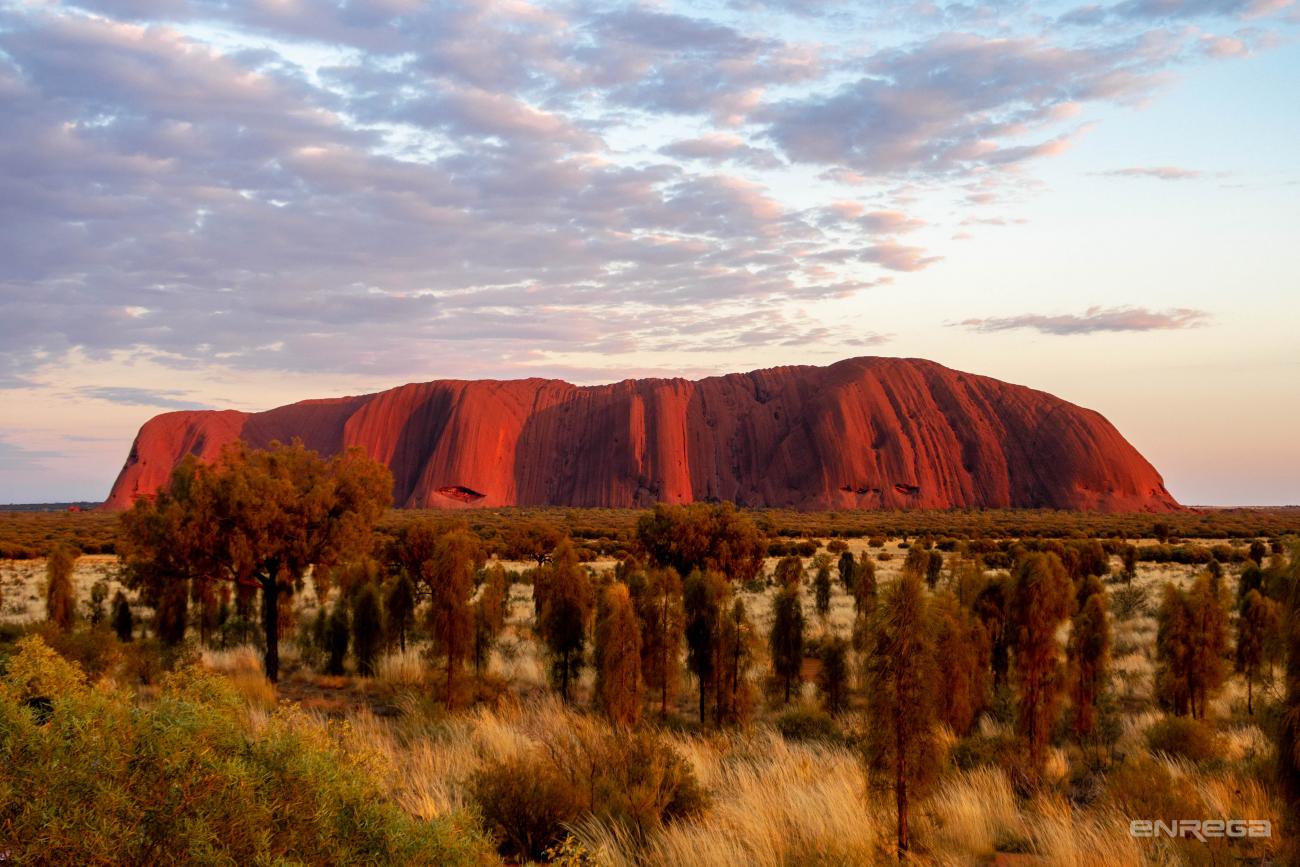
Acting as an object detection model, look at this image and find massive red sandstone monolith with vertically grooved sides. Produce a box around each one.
[105,357,1179,512]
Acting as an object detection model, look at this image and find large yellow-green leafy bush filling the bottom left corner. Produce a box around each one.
[0,637,495,864]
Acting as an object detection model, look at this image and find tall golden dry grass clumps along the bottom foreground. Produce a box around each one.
[330,698,1281,867]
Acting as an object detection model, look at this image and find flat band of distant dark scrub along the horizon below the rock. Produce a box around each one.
[0,507,1300,563]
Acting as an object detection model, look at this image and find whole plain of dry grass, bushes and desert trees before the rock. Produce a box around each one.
[0,447,1300,867]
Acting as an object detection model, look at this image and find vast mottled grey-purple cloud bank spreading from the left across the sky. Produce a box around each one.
[0,0,1274,387]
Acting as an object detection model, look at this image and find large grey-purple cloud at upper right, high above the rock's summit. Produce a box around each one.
[757,34,1182,177]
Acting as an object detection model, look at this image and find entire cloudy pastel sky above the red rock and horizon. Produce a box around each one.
[0,0,1300,506]
